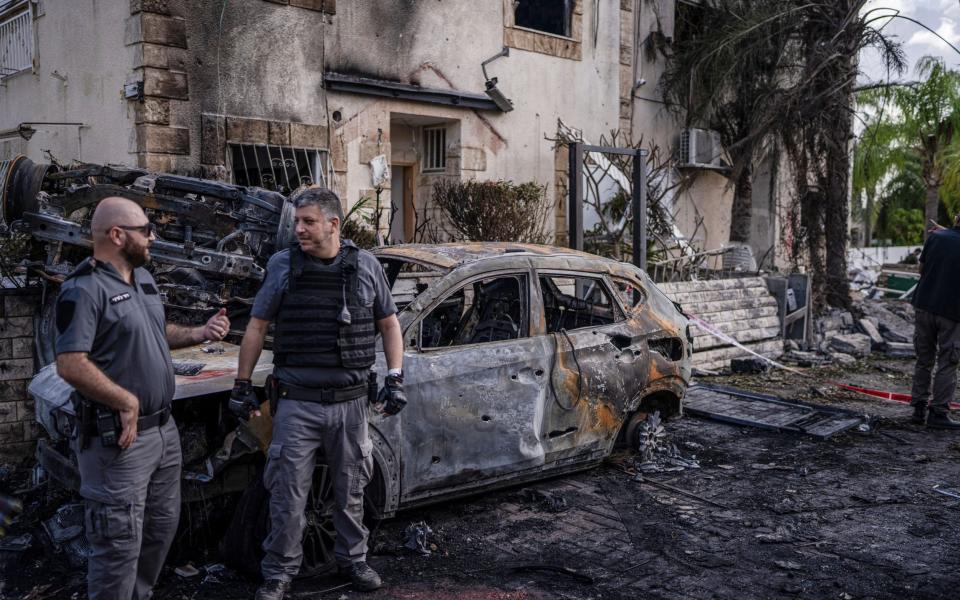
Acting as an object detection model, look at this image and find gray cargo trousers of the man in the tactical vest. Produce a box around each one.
[260,395,373,581]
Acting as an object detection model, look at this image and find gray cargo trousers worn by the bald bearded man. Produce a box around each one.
[77,417,182,600]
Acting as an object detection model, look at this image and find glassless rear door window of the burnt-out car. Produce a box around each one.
[540,275,620,333]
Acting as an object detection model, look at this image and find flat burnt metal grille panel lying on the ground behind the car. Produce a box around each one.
[684,384,868,438]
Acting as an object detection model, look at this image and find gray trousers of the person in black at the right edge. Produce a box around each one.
[910,308,960,413]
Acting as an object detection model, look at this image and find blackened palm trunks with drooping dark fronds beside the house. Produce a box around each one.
[661,0,903,306]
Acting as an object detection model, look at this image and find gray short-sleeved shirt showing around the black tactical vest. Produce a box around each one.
[250,240,397,387]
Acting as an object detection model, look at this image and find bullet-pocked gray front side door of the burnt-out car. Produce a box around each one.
[402,270,550,501]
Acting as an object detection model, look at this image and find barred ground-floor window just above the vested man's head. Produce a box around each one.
[230,144,327,194]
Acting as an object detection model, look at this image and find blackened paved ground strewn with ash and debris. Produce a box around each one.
[1,354,960,599]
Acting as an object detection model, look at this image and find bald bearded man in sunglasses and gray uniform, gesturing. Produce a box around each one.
[56,197,230,600]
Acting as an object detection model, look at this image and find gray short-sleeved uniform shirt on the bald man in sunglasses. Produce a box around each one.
[56,259,176,415]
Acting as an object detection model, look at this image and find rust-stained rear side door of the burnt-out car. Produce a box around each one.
[537,270,649,465]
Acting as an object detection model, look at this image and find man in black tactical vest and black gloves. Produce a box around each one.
[230,187,406,600]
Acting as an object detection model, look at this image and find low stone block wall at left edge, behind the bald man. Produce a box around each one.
[0,288,41,464]
